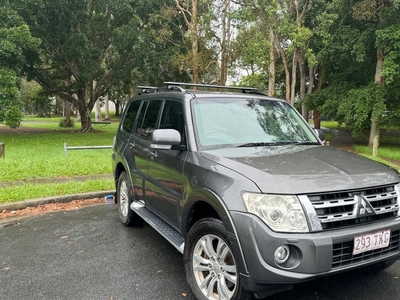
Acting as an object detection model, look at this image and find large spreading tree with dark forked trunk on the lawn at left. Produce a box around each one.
[14,0,147,132]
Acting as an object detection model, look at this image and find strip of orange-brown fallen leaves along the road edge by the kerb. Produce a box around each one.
[0,198,104,219]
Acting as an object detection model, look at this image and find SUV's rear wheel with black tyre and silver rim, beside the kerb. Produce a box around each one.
[117,172,143,226]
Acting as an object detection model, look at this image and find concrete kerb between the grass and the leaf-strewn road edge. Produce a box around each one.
[0,190,115,213]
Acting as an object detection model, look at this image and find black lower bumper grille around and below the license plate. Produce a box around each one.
[332,230,400,269]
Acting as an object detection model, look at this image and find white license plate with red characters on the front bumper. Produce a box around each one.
[353,229,390,255]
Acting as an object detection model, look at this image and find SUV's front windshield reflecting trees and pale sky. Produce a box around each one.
[192,98,319,150]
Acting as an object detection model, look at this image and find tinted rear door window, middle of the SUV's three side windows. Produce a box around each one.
[136,100,162,139]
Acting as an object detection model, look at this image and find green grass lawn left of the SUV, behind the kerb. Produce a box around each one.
[0,118,118,203]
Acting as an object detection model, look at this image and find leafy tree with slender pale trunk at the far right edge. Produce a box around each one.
[332,0,400,149]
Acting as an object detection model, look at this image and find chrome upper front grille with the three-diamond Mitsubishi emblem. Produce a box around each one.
[308,185,399,230]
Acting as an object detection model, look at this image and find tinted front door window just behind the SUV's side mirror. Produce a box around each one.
[160,101,185,143]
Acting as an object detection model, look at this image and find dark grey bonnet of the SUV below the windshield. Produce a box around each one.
[202,145,399,195]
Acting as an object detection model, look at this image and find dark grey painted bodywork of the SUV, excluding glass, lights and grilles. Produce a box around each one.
[112,86,400,295]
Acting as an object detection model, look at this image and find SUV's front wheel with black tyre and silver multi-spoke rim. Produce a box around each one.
[183,218,253,300]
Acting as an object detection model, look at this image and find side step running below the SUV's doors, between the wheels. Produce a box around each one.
[131,201,185,254]
